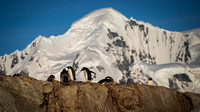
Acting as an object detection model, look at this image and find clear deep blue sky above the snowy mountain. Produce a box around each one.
[0,0,200,56]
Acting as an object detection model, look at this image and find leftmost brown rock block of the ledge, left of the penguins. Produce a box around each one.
[0,75,43,112]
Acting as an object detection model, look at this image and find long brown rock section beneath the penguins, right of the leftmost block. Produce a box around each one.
[43,83,200,112]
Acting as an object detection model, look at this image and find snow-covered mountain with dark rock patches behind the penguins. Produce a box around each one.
[0,8,200,93]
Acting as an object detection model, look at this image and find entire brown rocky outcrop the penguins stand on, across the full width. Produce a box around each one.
[0,75,200,112]
